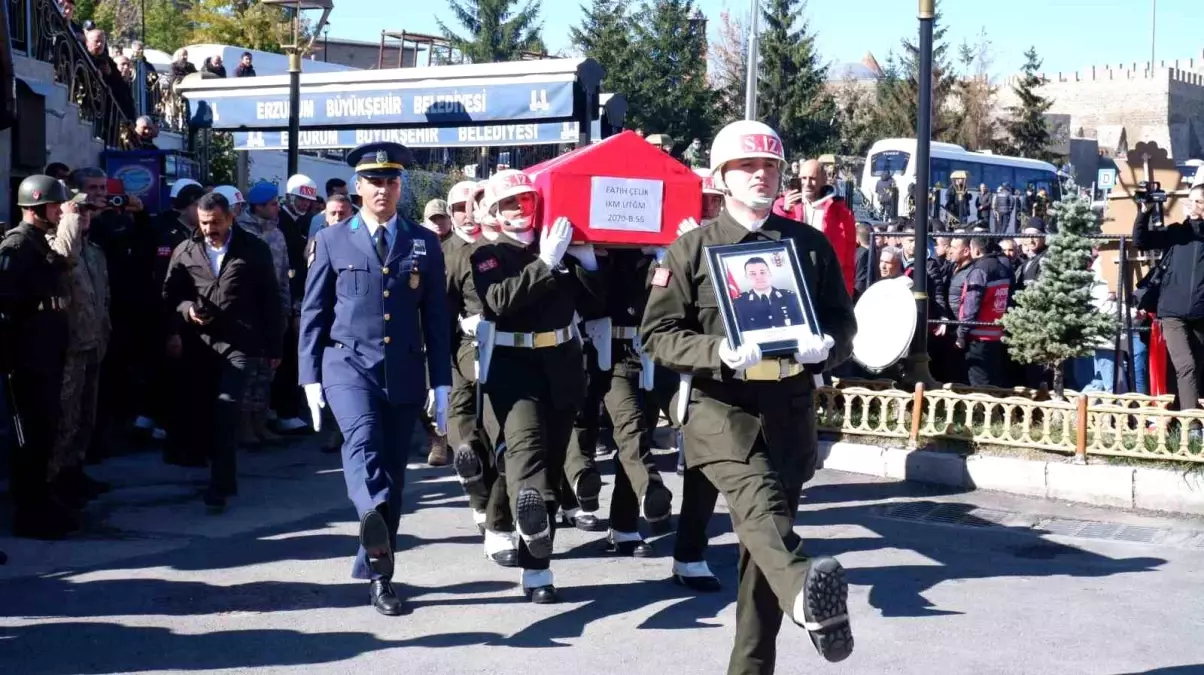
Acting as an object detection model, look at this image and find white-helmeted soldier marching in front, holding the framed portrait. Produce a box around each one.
[641,120,856,675]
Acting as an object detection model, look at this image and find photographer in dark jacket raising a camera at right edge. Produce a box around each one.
[1133,184,1204,413]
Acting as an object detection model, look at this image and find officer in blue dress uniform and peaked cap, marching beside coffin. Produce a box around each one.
[299,143,452,616]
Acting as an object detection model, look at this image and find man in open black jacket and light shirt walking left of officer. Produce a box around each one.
[163,193,284,510]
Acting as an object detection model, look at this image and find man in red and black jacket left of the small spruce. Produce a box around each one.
[957,237,1013,386]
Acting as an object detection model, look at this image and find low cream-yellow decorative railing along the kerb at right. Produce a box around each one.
[816,380,1204,463]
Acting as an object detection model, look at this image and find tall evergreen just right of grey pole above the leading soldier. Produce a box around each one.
[757,0,837,156]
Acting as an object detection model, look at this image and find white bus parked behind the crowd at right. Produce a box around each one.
[861,138,1062,218]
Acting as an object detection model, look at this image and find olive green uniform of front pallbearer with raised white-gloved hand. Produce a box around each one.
[470,238,604,570]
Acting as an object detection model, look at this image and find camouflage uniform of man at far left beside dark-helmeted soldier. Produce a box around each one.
[47,215,112,479]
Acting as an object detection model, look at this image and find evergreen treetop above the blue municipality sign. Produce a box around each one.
[436,0,544,64]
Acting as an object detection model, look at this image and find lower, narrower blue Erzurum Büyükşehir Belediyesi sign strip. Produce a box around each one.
[231,120,602,150]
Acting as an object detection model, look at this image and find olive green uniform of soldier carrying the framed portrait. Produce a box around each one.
[641,212,856,675]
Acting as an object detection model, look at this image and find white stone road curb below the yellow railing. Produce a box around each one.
[820,440,1204,515]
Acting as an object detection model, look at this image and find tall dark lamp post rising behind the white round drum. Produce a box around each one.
[904,0,937,386]
